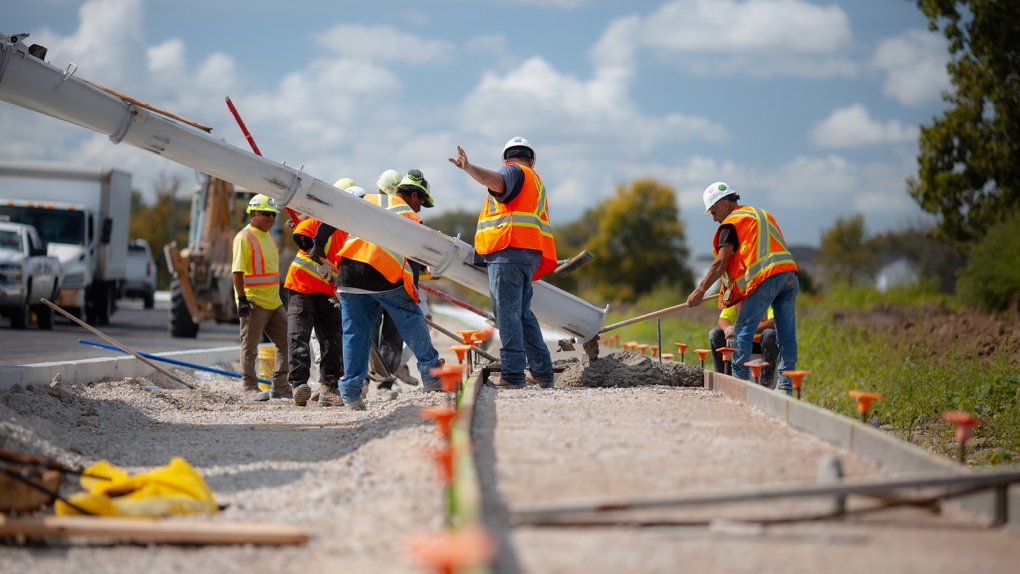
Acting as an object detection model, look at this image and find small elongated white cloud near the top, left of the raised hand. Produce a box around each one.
[316,24,454,64]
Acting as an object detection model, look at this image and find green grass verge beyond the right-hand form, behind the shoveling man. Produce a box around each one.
[606,288,1020,464]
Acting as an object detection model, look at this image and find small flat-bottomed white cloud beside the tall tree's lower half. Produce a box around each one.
[809,104,920,148]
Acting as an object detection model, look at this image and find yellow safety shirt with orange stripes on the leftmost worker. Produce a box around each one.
[232,225,284,309]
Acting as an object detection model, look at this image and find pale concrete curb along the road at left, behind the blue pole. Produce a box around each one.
[0,347,241,390]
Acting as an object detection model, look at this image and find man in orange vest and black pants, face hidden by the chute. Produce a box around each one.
[284,180,365,407]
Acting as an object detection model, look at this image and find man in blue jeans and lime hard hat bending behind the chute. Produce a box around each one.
[322,169,443,411]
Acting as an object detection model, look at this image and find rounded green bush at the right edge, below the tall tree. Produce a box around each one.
[957,213,1020,313]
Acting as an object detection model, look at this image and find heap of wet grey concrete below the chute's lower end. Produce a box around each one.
[557,351,705,387]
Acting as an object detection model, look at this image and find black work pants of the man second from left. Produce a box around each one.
[287,290,344,388]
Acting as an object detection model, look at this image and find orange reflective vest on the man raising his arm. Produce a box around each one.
[474,164,556,280]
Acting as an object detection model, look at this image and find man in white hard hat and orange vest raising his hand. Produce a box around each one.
[450,138,556,388]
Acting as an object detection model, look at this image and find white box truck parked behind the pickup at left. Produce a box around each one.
[0,161,131,325]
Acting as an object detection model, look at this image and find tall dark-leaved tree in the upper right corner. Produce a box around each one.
[908,0,1020,249]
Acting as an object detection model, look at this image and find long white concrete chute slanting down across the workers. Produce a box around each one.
[0,34,608,341]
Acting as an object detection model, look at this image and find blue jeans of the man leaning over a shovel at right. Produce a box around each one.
[733,271,801,395]
